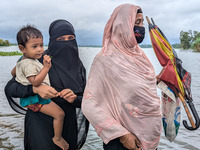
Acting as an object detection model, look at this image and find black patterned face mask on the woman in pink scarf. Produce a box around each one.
[134,26,145,44]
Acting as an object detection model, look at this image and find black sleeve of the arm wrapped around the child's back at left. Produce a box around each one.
[4,78,35,98]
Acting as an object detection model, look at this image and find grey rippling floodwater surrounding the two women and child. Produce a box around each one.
[0,46,200,150]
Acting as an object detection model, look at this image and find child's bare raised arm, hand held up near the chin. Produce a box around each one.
[27,55,51,86]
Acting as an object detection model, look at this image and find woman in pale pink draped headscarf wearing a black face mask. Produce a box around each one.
[82,4,162,150]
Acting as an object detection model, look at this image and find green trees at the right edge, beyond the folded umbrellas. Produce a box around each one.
[180,30,200,51]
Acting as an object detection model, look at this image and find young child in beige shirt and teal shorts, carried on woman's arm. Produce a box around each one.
[11,25,69,150]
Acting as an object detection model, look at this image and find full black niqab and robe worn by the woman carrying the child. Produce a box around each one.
[5,20,89,150]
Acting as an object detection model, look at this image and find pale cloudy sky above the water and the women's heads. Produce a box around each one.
[0,0,200,45]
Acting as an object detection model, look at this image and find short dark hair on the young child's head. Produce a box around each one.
[17,24,43,47]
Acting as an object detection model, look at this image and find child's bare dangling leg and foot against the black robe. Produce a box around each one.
[40,101,69,150]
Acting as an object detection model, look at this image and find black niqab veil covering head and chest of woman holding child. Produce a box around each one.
[48,20,85,94]
